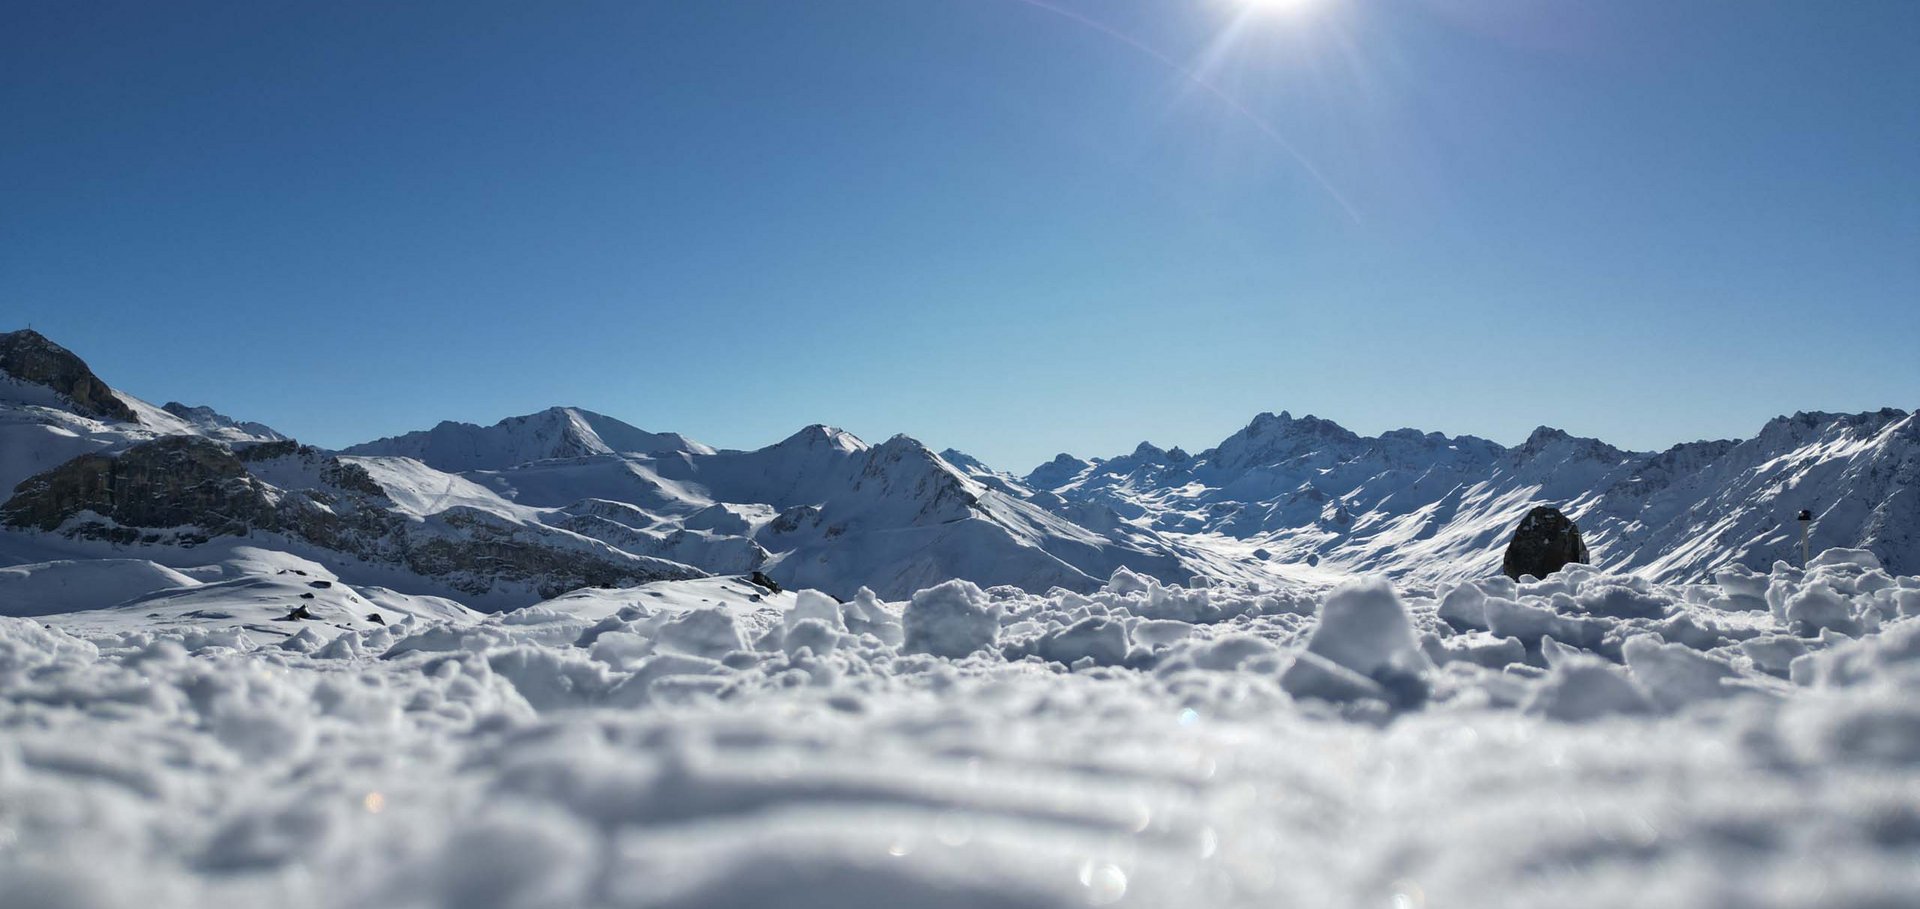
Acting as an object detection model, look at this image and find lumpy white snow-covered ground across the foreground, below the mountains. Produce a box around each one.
[0,550,1920,907]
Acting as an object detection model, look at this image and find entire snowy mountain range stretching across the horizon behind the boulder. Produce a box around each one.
[0,331,1920,607]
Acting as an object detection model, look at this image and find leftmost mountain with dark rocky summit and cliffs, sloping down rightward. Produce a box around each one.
[0,331,705,605]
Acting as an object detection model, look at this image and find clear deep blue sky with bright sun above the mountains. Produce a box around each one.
[0,0,1920,471]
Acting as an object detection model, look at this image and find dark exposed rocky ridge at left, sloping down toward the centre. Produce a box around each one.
[0,436,701,596]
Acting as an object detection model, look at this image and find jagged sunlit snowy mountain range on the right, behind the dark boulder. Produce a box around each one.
[1023,409,1920,580]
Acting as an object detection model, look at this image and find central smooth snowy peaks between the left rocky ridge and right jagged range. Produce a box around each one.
[328,407,1192,598]
